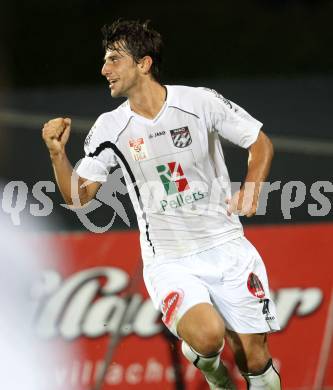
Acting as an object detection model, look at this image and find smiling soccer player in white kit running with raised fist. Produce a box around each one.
[43,20,281,390]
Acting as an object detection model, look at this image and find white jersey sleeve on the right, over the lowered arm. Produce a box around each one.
[203,89,263,148]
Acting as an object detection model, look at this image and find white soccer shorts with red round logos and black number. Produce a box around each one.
[143,237,280,337]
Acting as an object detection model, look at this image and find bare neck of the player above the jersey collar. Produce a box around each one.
[129,80,167,119]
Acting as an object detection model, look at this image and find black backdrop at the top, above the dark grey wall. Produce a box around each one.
[0,0,333,87]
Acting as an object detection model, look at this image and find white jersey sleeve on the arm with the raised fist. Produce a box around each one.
[76,116,118,182]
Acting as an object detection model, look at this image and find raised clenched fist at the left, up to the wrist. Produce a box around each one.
[42,118,71,155]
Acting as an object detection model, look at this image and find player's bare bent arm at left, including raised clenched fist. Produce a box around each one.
[43,118,101,206]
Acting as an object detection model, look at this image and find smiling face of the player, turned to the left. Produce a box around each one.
[102,43,140,97]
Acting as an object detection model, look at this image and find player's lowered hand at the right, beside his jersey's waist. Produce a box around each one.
[225,182,260,217]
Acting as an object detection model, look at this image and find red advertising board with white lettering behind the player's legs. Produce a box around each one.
[35,224,333,390]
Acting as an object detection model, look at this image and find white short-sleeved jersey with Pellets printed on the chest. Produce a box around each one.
[77,86,262,264]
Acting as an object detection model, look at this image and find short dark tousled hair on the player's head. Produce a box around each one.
[102,19,163,80]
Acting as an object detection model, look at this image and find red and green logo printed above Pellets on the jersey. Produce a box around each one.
[156,161,190,195]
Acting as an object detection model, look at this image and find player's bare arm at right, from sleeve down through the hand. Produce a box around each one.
[226,131,274,217]
